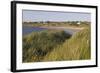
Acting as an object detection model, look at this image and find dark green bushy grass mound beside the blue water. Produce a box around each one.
[23,30,71,62]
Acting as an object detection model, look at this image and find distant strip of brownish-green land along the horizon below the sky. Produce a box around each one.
[23,21,90,27]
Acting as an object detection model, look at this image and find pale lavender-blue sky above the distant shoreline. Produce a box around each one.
[22,10,91,22]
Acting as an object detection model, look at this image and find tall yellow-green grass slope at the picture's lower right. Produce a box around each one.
[43,28,91,61]
